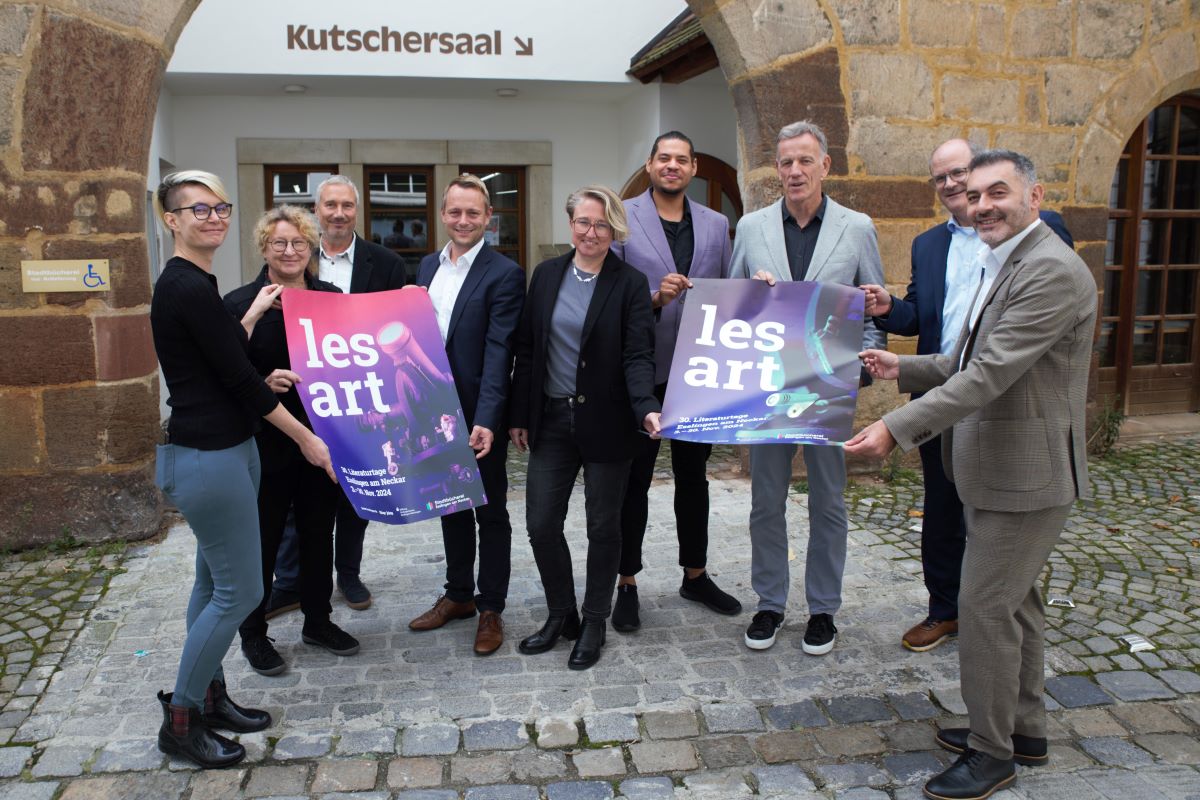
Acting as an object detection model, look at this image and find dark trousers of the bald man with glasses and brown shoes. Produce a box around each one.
[919,437,967,619]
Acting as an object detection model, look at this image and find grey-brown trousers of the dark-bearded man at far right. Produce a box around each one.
[959,504,1070,759]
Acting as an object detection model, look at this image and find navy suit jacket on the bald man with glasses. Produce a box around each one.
[875,211,1075,355]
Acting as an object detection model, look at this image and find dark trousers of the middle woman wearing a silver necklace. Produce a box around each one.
[526,399,629,619]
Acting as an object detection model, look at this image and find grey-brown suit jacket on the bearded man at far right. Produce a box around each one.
[883,224,1096,511]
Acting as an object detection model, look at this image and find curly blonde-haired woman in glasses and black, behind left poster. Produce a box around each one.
[226,205,359,675]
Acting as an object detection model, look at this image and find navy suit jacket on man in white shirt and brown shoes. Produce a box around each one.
[416,242,526,437]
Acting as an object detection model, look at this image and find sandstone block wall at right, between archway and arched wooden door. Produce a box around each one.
[689,0,1200,470]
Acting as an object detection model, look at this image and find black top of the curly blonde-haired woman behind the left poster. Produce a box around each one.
[224,265,342,471]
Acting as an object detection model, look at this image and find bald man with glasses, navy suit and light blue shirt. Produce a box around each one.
[863,139,1074,652]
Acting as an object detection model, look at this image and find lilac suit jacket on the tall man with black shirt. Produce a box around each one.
[612,190,732,384]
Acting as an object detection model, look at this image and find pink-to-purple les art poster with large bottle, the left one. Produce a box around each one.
[283,288,487,524]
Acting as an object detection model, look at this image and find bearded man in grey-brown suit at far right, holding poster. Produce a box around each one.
[846,150,1096,800]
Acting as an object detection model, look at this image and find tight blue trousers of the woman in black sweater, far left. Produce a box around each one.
[155,438,263,708]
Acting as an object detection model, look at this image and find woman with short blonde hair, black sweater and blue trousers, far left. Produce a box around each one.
[150,176,334,768]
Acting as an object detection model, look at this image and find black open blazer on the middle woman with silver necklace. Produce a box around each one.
[509,249,661,462]
